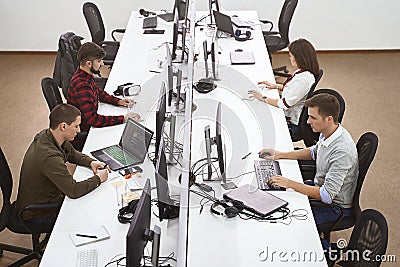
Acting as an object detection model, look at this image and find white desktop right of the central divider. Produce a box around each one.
[187,11,326,267]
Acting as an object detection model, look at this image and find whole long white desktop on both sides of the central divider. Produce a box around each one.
[40,9,326,267]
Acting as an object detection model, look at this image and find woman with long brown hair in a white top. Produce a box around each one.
[249,39,319,134]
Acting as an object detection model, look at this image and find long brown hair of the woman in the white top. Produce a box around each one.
[288,38,319,78]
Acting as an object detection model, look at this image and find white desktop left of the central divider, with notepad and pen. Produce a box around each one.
[40,12,183,267]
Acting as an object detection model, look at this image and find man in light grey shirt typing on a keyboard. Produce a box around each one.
[259,94,358,225]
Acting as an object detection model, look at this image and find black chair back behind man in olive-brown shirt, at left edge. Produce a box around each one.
[0,147,13,231]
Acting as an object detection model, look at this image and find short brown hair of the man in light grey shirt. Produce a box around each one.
[304,93,340,124]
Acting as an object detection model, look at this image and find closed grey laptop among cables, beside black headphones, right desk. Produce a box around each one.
[224,184,288,217]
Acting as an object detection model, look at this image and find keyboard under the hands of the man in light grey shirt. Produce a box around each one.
[254,160,285,190]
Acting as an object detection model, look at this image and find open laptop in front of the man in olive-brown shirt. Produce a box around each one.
[91,118,153,171]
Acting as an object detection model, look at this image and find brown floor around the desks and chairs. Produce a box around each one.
[0,52,400,266]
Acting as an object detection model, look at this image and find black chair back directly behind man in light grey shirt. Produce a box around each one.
[352,132,378,221]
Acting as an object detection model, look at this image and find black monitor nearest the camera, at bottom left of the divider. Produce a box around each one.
[126,179,151,267]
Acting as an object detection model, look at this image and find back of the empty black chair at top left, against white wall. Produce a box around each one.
[83,2,106,44]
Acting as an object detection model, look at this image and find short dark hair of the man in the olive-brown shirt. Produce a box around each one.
[49,103,81,130]
